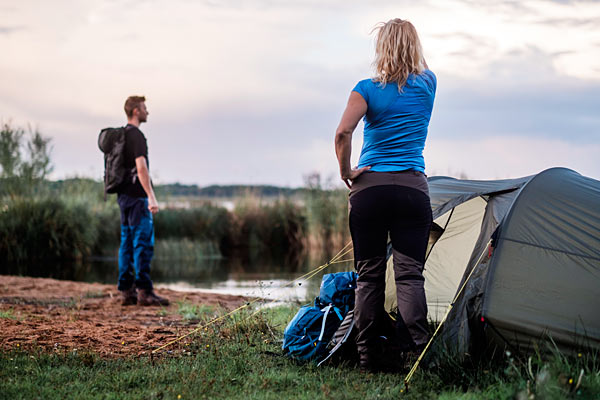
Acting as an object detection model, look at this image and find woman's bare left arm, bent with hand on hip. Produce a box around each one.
[335,91,371,188]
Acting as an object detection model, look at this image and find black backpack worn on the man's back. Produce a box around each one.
[98,127,137,196]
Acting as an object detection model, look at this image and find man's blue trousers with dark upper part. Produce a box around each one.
[117,194,154,290]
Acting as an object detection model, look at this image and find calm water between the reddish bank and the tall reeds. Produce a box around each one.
[0,257,352,304]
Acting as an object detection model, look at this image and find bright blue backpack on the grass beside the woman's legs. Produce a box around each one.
[282,272,357,361]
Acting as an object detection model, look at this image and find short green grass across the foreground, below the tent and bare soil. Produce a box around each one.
[0,307,600,400]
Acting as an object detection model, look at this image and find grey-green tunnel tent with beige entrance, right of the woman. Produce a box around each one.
[386,168,600,354]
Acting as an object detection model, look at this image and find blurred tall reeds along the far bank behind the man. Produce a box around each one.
[0,174,349,262]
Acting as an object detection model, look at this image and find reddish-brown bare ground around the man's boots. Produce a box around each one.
[0,275,247,357]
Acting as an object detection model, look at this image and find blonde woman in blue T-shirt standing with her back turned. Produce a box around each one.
[335,19,437,370]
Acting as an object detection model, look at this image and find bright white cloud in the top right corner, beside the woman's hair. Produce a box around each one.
[419,0,600,80]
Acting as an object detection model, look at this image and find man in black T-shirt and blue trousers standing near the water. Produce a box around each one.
[117,96,169,306]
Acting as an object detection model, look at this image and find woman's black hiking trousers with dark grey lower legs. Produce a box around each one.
[350,184,432,357]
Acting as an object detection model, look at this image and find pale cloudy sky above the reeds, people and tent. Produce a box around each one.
[0,0,600,187]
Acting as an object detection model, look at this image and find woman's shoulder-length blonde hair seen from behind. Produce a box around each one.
[373,18,425,91]
